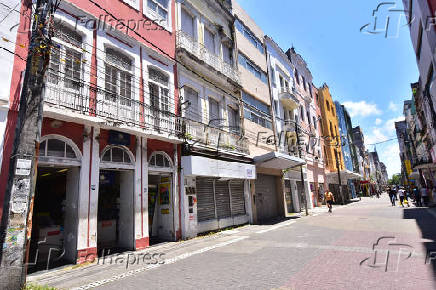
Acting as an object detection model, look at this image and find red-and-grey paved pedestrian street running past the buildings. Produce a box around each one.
[29,194,436,289]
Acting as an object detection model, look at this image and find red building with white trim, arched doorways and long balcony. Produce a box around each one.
[0,0,183,263]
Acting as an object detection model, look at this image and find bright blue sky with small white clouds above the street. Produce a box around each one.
[238,0,419,176]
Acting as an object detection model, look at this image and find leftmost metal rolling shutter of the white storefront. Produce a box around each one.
[196,177,215,222]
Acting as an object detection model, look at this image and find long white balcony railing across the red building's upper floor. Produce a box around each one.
[44,83,182,136]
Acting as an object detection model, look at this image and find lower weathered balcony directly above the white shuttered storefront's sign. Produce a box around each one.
[183,119,249,154]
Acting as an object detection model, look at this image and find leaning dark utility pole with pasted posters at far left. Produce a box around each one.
[0,0,60,289]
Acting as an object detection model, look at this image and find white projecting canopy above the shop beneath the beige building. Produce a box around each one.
[253,151,306,170]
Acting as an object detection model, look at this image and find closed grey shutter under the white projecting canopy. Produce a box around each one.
[255,174,279,222]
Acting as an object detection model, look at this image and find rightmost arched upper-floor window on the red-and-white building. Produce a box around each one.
[148,67,170,114]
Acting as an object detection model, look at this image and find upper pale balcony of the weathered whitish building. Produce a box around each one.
[176,30,240,85]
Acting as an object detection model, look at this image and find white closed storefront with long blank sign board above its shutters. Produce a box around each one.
[182,156,256,238]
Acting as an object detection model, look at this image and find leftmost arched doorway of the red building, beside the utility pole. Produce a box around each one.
[28,134,82,272]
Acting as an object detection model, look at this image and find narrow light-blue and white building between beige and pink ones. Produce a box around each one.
[265,36,311,214]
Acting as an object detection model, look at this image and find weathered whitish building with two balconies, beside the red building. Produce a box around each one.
[176,0,254,238]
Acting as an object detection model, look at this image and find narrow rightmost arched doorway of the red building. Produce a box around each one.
[148,151,175,244]
